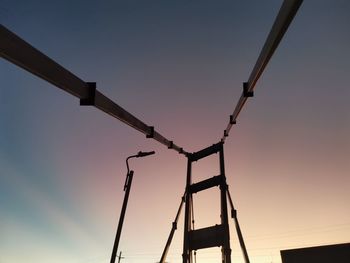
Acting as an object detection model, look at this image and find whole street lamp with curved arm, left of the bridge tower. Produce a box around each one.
[110,151,155,263]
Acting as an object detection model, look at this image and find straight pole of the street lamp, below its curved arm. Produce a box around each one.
[110,171,134,263]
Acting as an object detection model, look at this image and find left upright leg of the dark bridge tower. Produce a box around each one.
[182,157,192,263]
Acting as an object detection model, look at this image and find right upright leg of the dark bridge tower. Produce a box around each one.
[220,144,231,263]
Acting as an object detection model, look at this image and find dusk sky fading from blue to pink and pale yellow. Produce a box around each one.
[0,0,350,263]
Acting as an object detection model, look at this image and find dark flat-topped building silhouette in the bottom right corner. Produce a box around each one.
[281,243,350,263]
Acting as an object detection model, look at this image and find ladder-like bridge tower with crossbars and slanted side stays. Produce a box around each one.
[160,142,249,263]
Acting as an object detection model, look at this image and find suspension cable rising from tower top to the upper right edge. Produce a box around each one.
[221,0,303,142]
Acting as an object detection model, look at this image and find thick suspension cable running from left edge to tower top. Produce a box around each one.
[0,25,188,155]
